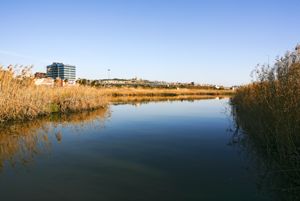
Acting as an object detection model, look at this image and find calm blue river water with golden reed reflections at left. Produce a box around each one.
[0,99,270,201]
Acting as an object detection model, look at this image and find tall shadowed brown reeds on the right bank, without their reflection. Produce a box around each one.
[231,64,300,156]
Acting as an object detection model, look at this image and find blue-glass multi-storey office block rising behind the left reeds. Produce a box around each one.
[47,63,76,82]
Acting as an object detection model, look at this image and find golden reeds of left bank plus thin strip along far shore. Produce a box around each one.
[0,66,233,123]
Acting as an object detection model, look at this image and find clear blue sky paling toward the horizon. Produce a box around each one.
[0,0,300,85]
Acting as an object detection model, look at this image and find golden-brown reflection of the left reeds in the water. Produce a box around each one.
[0,108,110,171]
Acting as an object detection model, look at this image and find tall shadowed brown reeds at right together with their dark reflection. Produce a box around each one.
[231,47,300,200]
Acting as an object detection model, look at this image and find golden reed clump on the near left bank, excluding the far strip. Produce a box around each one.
[0,66,108,122]
